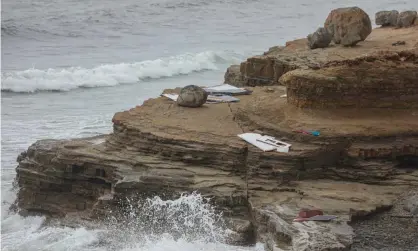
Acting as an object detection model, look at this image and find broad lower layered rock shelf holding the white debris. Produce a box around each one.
[13,86,418,250]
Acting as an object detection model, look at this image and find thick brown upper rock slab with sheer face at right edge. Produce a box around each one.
[281,47,418,109]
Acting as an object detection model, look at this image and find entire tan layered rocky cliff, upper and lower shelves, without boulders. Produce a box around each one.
[12,7,418,251]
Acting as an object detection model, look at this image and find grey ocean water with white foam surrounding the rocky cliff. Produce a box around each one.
[1,0,418,251]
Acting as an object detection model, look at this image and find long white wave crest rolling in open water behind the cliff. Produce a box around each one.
[1,51,229,92]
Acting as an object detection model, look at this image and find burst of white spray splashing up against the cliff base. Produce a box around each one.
[105,192,229,247]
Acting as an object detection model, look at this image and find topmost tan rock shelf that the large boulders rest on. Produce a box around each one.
[225,26,418,86]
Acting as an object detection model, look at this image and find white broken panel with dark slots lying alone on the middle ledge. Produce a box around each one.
[238,133,291,153]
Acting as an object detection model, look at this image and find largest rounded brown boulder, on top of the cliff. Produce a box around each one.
[324,7,372,46]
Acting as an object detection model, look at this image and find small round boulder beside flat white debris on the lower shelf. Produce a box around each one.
[177,85,208,107]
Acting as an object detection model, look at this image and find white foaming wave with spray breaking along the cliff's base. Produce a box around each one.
[1,193,261,251]
